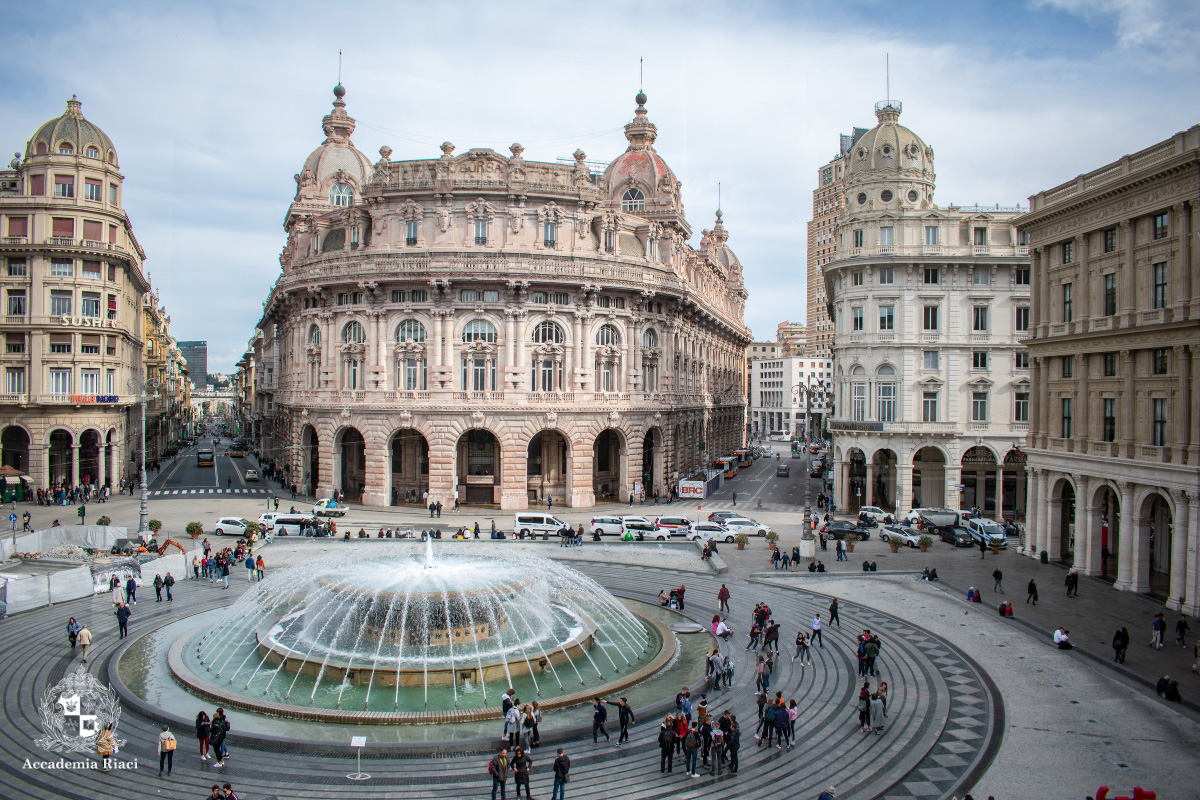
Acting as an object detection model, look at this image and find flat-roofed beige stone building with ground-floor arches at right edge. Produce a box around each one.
[1016,126,1200,614]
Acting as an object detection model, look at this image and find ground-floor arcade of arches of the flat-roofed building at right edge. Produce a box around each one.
[1026,468,1200,614]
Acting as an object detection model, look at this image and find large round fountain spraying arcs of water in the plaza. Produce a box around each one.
[168,541,674,723]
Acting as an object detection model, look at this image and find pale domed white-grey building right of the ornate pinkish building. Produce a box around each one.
[823,101,1030,518]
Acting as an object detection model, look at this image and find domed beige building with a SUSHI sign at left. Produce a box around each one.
[0,97,150,487]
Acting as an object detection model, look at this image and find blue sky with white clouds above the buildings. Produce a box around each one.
[0,0,1200,372]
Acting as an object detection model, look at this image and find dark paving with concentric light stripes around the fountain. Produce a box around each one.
[0,561,1002,800]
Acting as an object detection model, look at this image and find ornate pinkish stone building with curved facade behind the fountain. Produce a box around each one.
[255,85,751,509]
